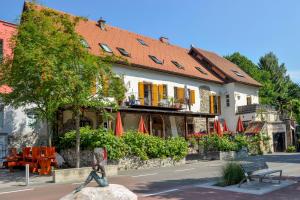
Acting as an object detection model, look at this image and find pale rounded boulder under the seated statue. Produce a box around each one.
[60,184,137,200]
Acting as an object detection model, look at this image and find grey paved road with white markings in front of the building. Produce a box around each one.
[0,154,300,200]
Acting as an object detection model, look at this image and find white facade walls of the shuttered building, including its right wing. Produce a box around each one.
[113,65,259,131]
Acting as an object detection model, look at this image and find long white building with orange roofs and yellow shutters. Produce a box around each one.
[33,3,261,140]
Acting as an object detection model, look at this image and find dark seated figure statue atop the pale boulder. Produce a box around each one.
[75,148,109,193]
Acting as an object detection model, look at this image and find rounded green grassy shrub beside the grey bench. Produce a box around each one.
[221,162,244,186]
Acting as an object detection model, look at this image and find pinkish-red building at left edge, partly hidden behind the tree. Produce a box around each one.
[0,20,47,163]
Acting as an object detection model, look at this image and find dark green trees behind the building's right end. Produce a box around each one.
[225,52,300,123]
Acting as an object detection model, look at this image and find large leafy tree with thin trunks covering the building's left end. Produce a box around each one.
[1,3,125,167]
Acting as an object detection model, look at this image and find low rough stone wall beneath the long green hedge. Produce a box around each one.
[60,149,185,170]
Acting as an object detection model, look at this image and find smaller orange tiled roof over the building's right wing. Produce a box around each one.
[193,48,262,87]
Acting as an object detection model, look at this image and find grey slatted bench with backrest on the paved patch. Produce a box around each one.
[239,160,282,187]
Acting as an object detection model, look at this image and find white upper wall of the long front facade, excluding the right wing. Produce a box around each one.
[113,65,223,112]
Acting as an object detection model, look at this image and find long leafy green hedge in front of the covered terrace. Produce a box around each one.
[59,127,188,160]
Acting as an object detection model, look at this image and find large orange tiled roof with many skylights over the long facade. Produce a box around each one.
[76,21,223,83]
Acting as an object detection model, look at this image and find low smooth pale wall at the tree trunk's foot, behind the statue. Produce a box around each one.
[53,165,118,183]
